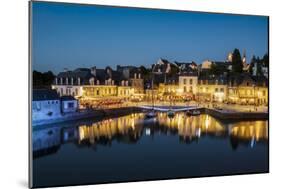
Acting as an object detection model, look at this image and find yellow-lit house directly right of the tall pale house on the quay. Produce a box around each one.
[197,76,228,102]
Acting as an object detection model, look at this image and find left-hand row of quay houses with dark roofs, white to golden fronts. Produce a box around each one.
[52,66,144,102]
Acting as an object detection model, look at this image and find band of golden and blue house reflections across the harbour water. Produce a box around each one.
[33,113,268,157]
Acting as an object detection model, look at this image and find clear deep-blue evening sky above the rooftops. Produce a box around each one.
[32,2,268,73]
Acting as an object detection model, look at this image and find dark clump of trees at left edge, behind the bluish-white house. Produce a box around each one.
[32,70,55,89]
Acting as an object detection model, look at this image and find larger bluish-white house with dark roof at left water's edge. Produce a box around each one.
[32,89,61,121]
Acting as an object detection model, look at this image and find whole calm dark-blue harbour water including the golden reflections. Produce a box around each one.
[33,113,268,187]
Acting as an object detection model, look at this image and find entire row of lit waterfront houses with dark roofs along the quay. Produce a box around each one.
[49,57,268,105]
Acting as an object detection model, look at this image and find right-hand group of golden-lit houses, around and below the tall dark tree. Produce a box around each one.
[145,56,268,105]
